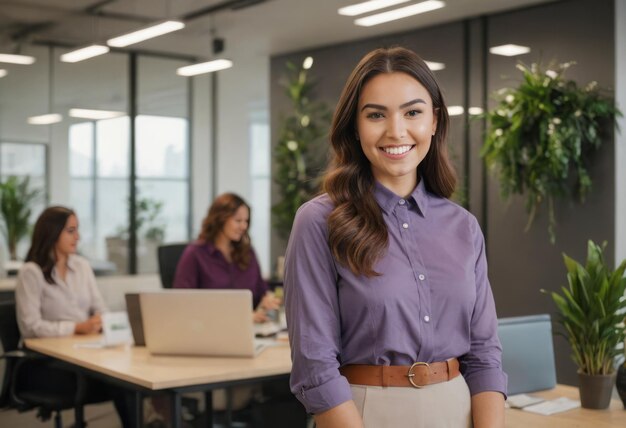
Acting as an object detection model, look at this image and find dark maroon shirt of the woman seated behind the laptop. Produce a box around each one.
[174,241,268,307]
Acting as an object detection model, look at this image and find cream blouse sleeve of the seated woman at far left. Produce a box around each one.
[15,263,76,338]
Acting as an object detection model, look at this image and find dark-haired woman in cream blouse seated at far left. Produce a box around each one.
[15,206,129,427]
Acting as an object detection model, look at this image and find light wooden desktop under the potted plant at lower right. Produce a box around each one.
[505,385,626,428]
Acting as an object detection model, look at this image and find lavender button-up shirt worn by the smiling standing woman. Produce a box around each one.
[285,180,507,413]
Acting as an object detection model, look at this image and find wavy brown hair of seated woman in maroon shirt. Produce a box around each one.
[198,193,252,269]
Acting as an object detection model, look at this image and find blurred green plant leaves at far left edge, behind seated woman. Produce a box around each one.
[0,176,41,260]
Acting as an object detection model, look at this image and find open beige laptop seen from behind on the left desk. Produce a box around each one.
[139,290,268,357]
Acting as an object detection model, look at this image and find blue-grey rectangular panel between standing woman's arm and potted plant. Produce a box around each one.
[498,314,556,395]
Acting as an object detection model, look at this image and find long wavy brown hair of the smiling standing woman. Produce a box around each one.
[323,47,456,277]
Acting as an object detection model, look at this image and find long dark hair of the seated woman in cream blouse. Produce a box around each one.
[26,206,76,284]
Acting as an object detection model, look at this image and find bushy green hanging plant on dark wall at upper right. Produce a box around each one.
[481,63,621,243]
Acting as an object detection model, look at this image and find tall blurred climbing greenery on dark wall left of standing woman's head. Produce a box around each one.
[272,57,330,239]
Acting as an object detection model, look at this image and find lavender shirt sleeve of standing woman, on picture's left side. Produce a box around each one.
[284,201,352,414]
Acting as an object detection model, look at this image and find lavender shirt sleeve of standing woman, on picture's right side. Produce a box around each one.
[461,217,507,398]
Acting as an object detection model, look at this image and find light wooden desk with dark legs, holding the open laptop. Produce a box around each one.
[25,335,291,427]
